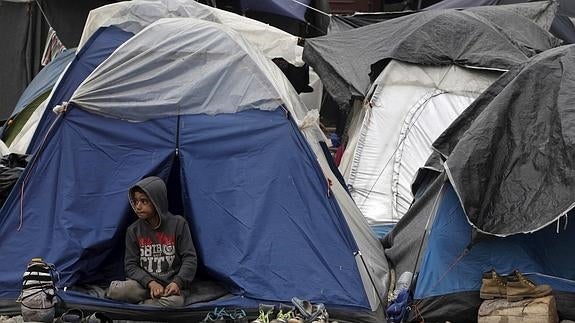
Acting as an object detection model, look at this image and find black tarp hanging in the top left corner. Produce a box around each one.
[0,0,48,120]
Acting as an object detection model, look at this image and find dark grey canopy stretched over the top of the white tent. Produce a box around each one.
[304,2,560,107]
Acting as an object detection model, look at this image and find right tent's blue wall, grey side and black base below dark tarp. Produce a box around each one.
[384,174,575,322]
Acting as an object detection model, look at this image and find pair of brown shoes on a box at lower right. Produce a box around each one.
[479,270,551,302]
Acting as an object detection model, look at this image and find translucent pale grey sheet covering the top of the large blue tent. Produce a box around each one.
[70,18,307,121]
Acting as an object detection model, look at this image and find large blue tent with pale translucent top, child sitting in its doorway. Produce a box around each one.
[0,19,387,322]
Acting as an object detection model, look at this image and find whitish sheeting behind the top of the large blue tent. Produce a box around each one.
[80,0,305,66]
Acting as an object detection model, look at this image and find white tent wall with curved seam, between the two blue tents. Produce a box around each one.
[340,61,500,225]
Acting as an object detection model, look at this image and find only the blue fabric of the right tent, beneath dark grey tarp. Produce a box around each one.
[415,184,575,299]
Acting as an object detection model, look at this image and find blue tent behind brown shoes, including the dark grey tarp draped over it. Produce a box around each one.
[384,45,575,322]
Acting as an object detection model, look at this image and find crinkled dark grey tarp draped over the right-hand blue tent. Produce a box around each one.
[433,45,575,236]
